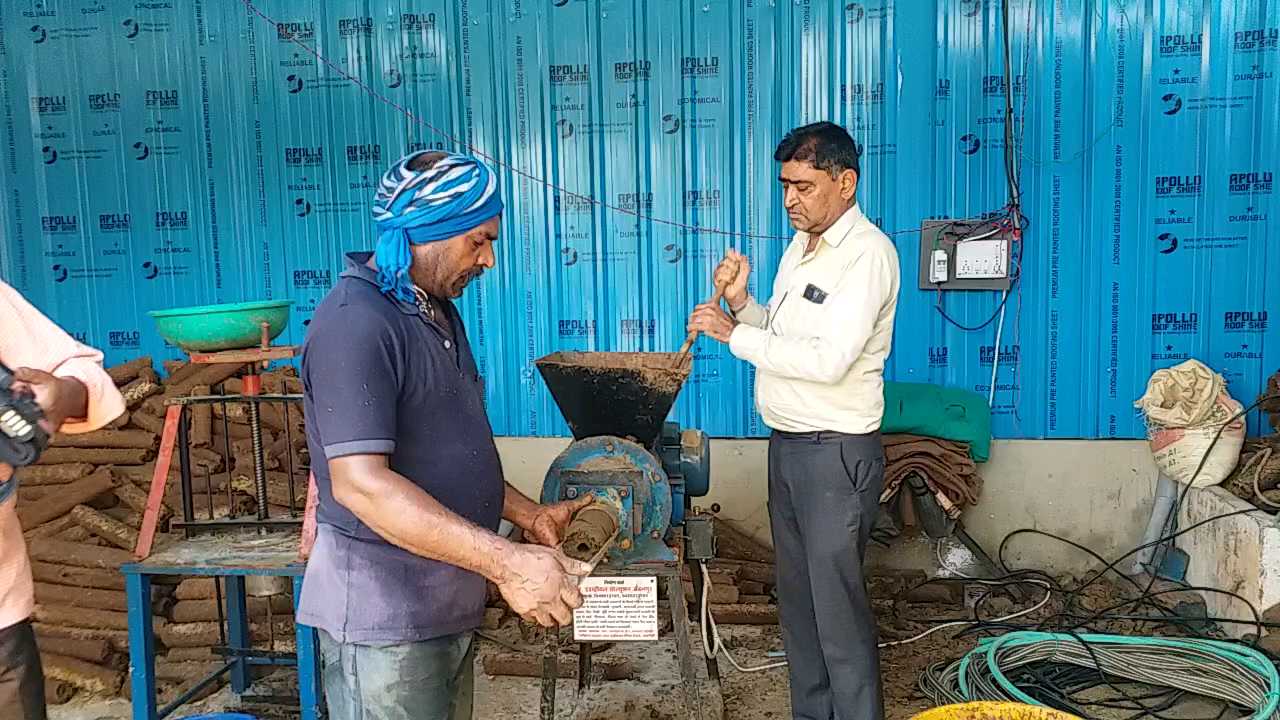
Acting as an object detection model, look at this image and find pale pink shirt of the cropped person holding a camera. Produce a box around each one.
[0,282,124,629]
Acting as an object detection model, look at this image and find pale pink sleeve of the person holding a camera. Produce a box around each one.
[0,282,124,433]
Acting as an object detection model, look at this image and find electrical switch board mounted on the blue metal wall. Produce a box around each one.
[919,218,1014,291]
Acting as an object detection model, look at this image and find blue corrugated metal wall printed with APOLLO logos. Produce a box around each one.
[0,0,1280,437]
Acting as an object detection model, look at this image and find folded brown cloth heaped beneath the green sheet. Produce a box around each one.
[881,434,982,518]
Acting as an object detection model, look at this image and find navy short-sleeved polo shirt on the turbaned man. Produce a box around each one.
[297,252,504,643]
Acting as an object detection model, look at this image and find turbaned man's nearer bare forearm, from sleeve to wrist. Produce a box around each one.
[330,459,511,582]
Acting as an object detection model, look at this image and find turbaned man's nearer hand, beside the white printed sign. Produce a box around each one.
[495,544,591,628]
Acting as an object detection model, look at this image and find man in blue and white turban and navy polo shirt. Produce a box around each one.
[297,152,590,720]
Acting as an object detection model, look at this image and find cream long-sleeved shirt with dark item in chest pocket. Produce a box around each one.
[730,205,899,434]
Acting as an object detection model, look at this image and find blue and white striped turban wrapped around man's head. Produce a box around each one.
[374,150,502,302]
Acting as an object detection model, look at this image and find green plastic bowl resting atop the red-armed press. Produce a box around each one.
[147,300,293,352]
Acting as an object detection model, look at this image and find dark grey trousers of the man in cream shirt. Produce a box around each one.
[769,432,884,720]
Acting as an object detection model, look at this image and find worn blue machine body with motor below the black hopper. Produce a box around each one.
[541,423,710,566]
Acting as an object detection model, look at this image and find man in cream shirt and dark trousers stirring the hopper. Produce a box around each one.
[689,123,899,720]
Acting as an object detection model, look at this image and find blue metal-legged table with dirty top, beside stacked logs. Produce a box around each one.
[120,530,320,720]
